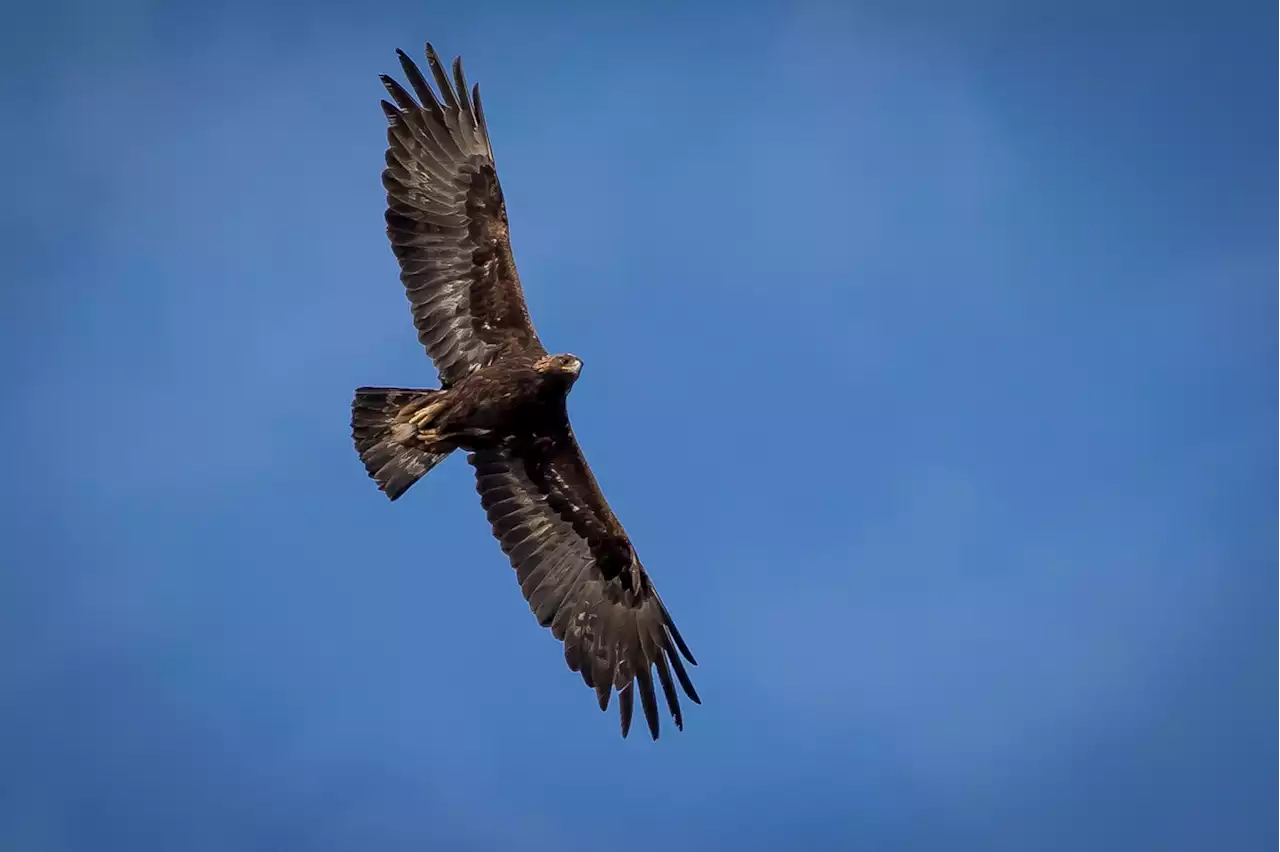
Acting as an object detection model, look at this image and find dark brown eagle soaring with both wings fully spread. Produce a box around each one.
[351,43,701,739]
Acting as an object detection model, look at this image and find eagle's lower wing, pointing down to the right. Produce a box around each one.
[468,426,701,739]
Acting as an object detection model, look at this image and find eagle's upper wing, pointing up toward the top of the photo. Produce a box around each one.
[381,45,544,385]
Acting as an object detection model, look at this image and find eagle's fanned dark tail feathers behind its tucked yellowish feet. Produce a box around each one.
[351,388,451,500]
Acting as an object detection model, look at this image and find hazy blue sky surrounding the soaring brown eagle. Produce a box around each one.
[0,1,1280,852]
